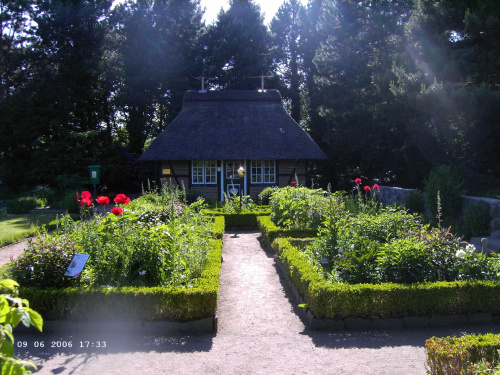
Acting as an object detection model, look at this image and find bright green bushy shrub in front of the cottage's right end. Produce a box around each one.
[270,186,329,229]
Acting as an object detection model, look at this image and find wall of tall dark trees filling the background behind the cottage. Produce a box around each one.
[0,0,500,194]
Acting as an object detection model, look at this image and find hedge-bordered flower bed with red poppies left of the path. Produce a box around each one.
[6,191,224,331]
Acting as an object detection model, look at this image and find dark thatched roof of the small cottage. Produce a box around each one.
[141,90,327,161]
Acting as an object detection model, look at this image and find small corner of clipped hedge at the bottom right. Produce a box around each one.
[425,333,500,375]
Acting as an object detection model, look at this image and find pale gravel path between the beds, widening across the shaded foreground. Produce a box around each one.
[4,232,500,375]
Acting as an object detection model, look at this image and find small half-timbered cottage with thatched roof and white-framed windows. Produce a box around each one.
[140,90,327,200]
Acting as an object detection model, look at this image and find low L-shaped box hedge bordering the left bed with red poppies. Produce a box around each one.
[19,240,222,322]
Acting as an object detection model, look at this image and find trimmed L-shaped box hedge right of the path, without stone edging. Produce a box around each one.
[272,238,500,319]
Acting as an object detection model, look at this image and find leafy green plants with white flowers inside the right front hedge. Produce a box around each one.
[307,207,500,284]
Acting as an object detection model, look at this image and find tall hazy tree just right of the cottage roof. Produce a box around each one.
[311,0,410,188]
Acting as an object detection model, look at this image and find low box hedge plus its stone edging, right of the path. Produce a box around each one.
[273,238,500,329]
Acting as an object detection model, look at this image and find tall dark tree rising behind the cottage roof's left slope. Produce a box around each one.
[114,0,201,153]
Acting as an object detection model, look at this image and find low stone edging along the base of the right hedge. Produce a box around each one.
[274,256,500,330]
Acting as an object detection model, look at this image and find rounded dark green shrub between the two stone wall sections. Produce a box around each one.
[425,165,463,223]
